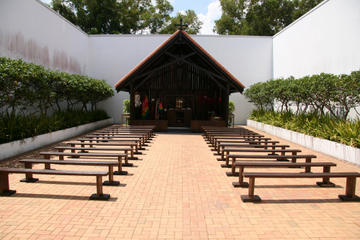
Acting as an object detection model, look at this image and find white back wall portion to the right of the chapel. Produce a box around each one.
[192,35,273,124]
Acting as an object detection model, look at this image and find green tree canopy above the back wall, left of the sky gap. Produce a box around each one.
[51,0,202,34]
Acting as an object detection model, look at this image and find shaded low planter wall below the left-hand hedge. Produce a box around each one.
[0,118,113,161]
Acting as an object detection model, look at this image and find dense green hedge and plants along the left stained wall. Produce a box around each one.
[0,57,114,143]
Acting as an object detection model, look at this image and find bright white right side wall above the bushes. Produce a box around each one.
[273,0,360,78]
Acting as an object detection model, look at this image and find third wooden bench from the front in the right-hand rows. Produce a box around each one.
[226,154,316,176]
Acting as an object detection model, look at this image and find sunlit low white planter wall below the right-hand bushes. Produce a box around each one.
[247,120,360,165]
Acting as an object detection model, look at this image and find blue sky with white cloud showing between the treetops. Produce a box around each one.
[41,0,222,35]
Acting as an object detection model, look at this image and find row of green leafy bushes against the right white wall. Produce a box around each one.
[244,71,360,119]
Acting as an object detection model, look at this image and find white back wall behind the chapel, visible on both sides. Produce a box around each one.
[88,35,272,124]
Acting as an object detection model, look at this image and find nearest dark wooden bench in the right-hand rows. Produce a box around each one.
[241,172,360,202]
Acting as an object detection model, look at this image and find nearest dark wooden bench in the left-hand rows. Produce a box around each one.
[0,168,110,200]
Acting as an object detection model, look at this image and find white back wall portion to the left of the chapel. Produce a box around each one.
[88,35,170,122]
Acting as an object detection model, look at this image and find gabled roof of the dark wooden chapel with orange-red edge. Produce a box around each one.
[115,30,245,93]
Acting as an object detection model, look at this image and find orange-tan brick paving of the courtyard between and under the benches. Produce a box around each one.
[0,126,360,240]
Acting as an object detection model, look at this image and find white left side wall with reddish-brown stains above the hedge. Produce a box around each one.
[0,0,88,74]
